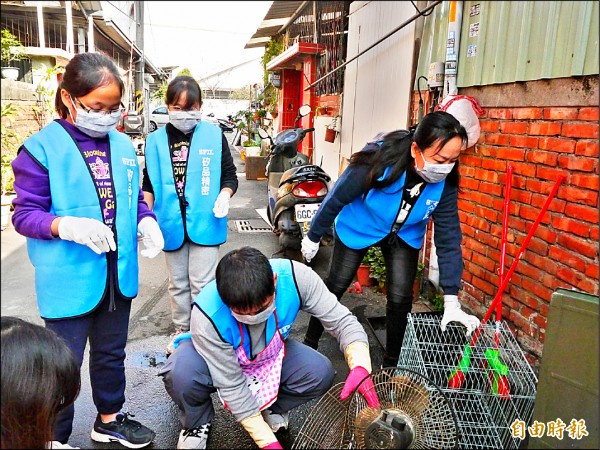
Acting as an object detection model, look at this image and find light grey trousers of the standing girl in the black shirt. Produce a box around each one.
[163,242,219,331]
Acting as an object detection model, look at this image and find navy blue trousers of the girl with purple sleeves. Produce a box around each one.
[45,294,131,444]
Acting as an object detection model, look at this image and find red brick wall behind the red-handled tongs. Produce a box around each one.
[414,89,599,365]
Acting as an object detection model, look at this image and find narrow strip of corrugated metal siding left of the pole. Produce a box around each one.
[415,2,450,89]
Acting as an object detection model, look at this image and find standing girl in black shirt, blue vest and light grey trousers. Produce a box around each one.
[142,75,238,354]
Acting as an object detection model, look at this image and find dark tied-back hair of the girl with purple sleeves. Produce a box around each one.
[54,53,125,119]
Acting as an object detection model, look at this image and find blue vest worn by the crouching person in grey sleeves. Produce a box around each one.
[194,259,300,355]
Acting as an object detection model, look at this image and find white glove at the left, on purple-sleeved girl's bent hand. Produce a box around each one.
[58,216,117,255]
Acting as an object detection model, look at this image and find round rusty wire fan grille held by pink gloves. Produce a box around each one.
[293,367,458,449]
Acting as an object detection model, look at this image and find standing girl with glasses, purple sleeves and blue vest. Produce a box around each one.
[13,53,163,448]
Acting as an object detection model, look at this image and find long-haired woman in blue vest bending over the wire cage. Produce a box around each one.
[302,111,479,366]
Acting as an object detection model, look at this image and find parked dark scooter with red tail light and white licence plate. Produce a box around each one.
[258,105,331,253]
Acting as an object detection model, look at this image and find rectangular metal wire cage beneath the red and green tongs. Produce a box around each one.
[398,314,537,448]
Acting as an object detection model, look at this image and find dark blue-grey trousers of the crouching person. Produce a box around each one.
[159,339,335,428]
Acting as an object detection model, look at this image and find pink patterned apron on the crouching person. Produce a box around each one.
[218,313,285,411]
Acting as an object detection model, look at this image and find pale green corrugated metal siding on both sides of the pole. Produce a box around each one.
[415,1,599,88]
